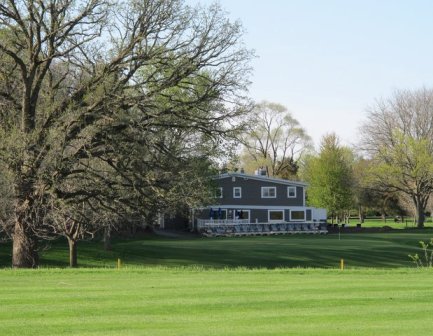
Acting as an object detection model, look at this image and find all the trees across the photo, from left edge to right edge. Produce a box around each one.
[0,0,433,267]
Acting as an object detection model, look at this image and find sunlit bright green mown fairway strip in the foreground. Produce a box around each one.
[0,267,433,336]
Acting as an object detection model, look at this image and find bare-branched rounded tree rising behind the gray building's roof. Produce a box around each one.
[241,101,311,178]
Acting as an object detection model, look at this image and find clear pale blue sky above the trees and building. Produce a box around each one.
[194,0,433,146]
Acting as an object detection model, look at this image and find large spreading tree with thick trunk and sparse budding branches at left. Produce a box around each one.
[0,0,251,267]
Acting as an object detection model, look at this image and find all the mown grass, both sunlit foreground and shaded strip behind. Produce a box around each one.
[0,229,433,336]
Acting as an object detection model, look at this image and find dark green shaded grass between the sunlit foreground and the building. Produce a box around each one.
[0,229,433,269]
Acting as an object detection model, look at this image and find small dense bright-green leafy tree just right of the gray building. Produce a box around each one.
[302,134,353,220]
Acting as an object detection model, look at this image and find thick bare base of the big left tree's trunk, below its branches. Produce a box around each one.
[12,221,39,268]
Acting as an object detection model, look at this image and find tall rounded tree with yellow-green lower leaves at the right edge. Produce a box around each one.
[362,88,433,227]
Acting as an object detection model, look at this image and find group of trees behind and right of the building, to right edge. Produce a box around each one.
[240,88,433,227]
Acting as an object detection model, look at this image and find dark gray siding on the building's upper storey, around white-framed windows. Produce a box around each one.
[215,176,304,206]
